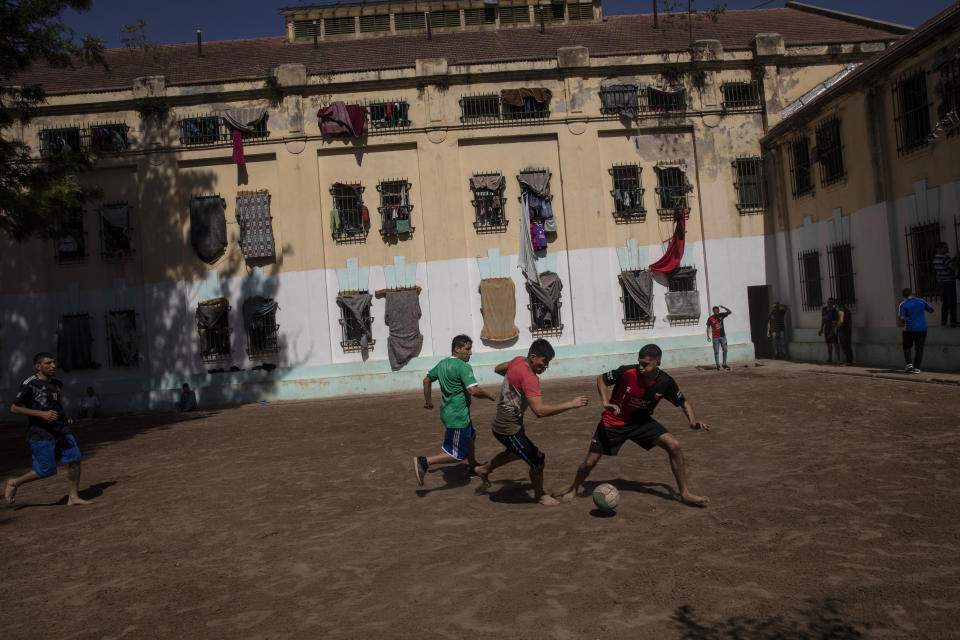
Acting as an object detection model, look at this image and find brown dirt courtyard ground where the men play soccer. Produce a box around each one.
[0,364,960,640]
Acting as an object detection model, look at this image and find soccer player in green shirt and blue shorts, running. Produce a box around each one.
[413,335,496,487]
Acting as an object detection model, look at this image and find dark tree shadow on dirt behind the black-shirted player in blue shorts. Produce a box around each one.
[0,411,217,475]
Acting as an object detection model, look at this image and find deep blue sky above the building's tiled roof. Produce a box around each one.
[64,0,951,47]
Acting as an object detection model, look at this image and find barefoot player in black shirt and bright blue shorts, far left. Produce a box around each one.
[3,352,90,505]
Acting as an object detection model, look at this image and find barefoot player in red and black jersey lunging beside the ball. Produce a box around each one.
[561,344,710,505]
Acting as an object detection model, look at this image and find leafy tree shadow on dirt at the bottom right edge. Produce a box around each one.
[670,598,876,640]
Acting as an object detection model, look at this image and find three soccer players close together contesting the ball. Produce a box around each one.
[413,335,710,505]
